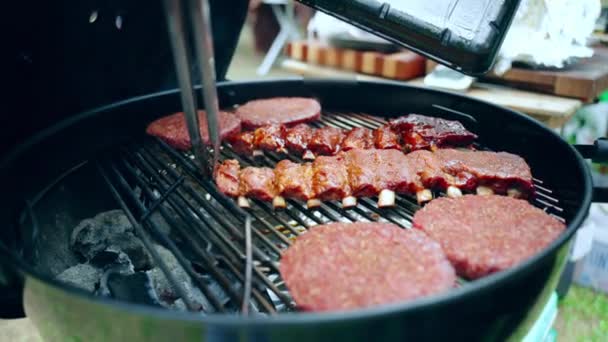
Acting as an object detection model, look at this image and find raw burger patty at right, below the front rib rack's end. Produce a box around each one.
[414,195,565,279]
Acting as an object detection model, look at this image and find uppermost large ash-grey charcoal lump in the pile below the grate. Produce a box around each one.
[70,210,152,270]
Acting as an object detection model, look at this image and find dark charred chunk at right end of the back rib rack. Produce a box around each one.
[389,114,477,151]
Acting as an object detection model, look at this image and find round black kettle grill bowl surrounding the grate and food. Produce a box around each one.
[0,80,591,340]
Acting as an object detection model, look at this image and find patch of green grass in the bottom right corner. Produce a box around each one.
[555,286,608,342]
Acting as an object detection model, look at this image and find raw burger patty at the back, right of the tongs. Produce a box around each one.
[236,97,321,129]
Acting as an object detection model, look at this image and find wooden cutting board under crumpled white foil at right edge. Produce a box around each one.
[427,46,608,102]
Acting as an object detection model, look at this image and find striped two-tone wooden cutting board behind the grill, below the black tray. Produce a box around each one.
[285,41,426,80]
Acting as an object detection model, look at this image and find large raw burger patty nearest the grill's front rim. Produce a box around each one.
[280,223,456,311]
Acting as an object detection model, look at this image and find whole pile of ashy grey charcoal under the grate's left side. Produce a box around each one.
[57,208,241,312]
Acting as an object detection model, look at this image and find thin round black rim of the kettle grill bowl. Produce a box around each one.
[0,79,593,327]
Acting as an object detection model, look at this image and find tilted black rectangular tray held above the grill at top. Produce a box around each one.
[298,0,519,75]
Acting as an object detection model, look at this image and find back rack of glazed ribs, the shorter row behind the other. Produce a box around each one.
[223,114,477,159]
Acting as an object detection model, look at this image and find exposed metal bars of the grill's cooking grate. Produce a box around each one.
[97,113,563,314]
